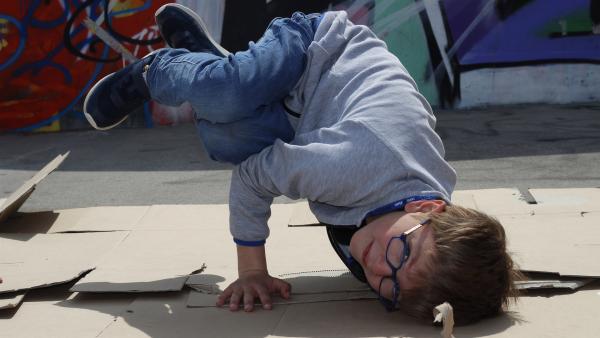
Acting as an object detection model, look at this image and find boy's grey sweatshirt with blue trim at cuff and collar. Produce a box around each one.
[229,12,456,245]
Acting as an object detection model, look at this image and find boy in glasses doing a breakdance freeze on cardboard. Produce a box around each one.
[84,4,514,324]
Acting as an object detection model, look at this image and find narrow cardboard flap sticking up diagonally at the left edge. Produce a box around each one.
[0,151,70,223]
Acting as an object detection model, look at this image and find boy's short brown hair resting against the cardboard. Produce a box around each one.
[400,205,522,325]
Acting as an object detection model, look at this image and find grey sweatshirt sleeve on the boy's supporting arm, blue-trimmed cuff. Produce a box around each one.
[229,120,393,246]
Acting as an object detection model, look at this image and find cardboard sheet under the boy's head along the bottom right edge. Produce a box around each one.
[269,289,600,338]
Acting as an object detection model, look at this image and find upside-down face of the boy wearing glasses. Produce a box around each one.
[350,200,446,298]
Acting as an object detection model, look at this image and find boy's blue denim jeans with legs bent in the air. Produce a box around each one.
[146,13,321,164]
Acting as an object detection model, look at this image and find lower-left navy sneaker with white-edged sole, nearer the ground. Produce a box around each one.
[83,52,155,130]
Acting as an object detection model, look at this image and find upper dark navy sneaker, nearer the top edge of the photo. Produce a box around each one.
[154,4,231,57]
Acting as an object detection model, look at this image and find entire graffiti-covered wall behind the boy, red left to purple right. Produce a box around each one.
[0,0,600,131]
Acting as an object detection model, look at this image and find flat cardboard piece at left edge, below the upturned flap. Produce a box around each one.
[0,232,127,293]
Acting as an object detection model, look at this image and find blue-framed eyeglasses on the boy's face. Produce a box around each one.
[377,219,429,311]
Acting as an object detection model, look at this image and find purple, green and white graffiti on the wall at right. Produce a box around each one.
[352,0,600,106]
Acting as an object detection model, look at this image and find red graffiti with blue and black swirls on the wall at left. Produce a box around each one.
[0,0,167,131]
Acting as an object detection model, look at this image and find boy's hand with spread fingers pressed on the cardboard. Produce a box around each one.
[217,270,292,312]
